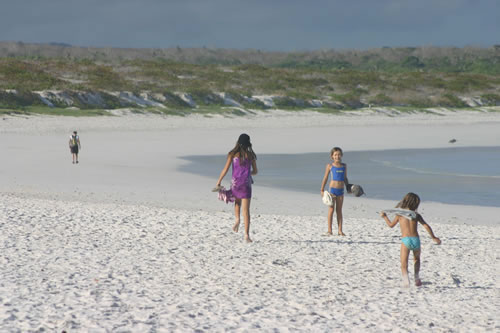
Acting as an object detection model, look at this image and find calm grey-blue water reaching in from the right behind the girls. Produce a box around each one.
[182,147,500,207]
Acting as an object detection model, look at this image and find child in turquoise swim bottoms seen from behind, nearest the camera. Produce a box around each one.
[380,192,441,287]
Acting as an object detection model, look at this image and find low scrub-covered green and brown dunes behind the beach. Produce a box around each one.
[0,42,500,114]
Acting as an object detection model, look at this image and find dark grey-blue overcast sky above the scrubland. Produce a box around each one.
[0,0,500,51]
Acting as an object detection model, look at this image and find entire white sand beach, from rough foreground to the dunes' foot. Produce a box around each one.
[0,108,500,332]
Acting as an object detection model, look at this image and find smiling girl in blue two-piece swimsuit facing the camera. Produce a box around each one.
[321,147,350,236]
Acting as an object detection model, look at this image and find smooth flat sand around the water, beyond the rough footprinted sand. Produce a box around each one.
[0,111,500,225]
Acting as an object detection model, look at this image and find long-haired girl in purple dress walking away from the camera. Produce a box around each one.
[216,134,257,242]
